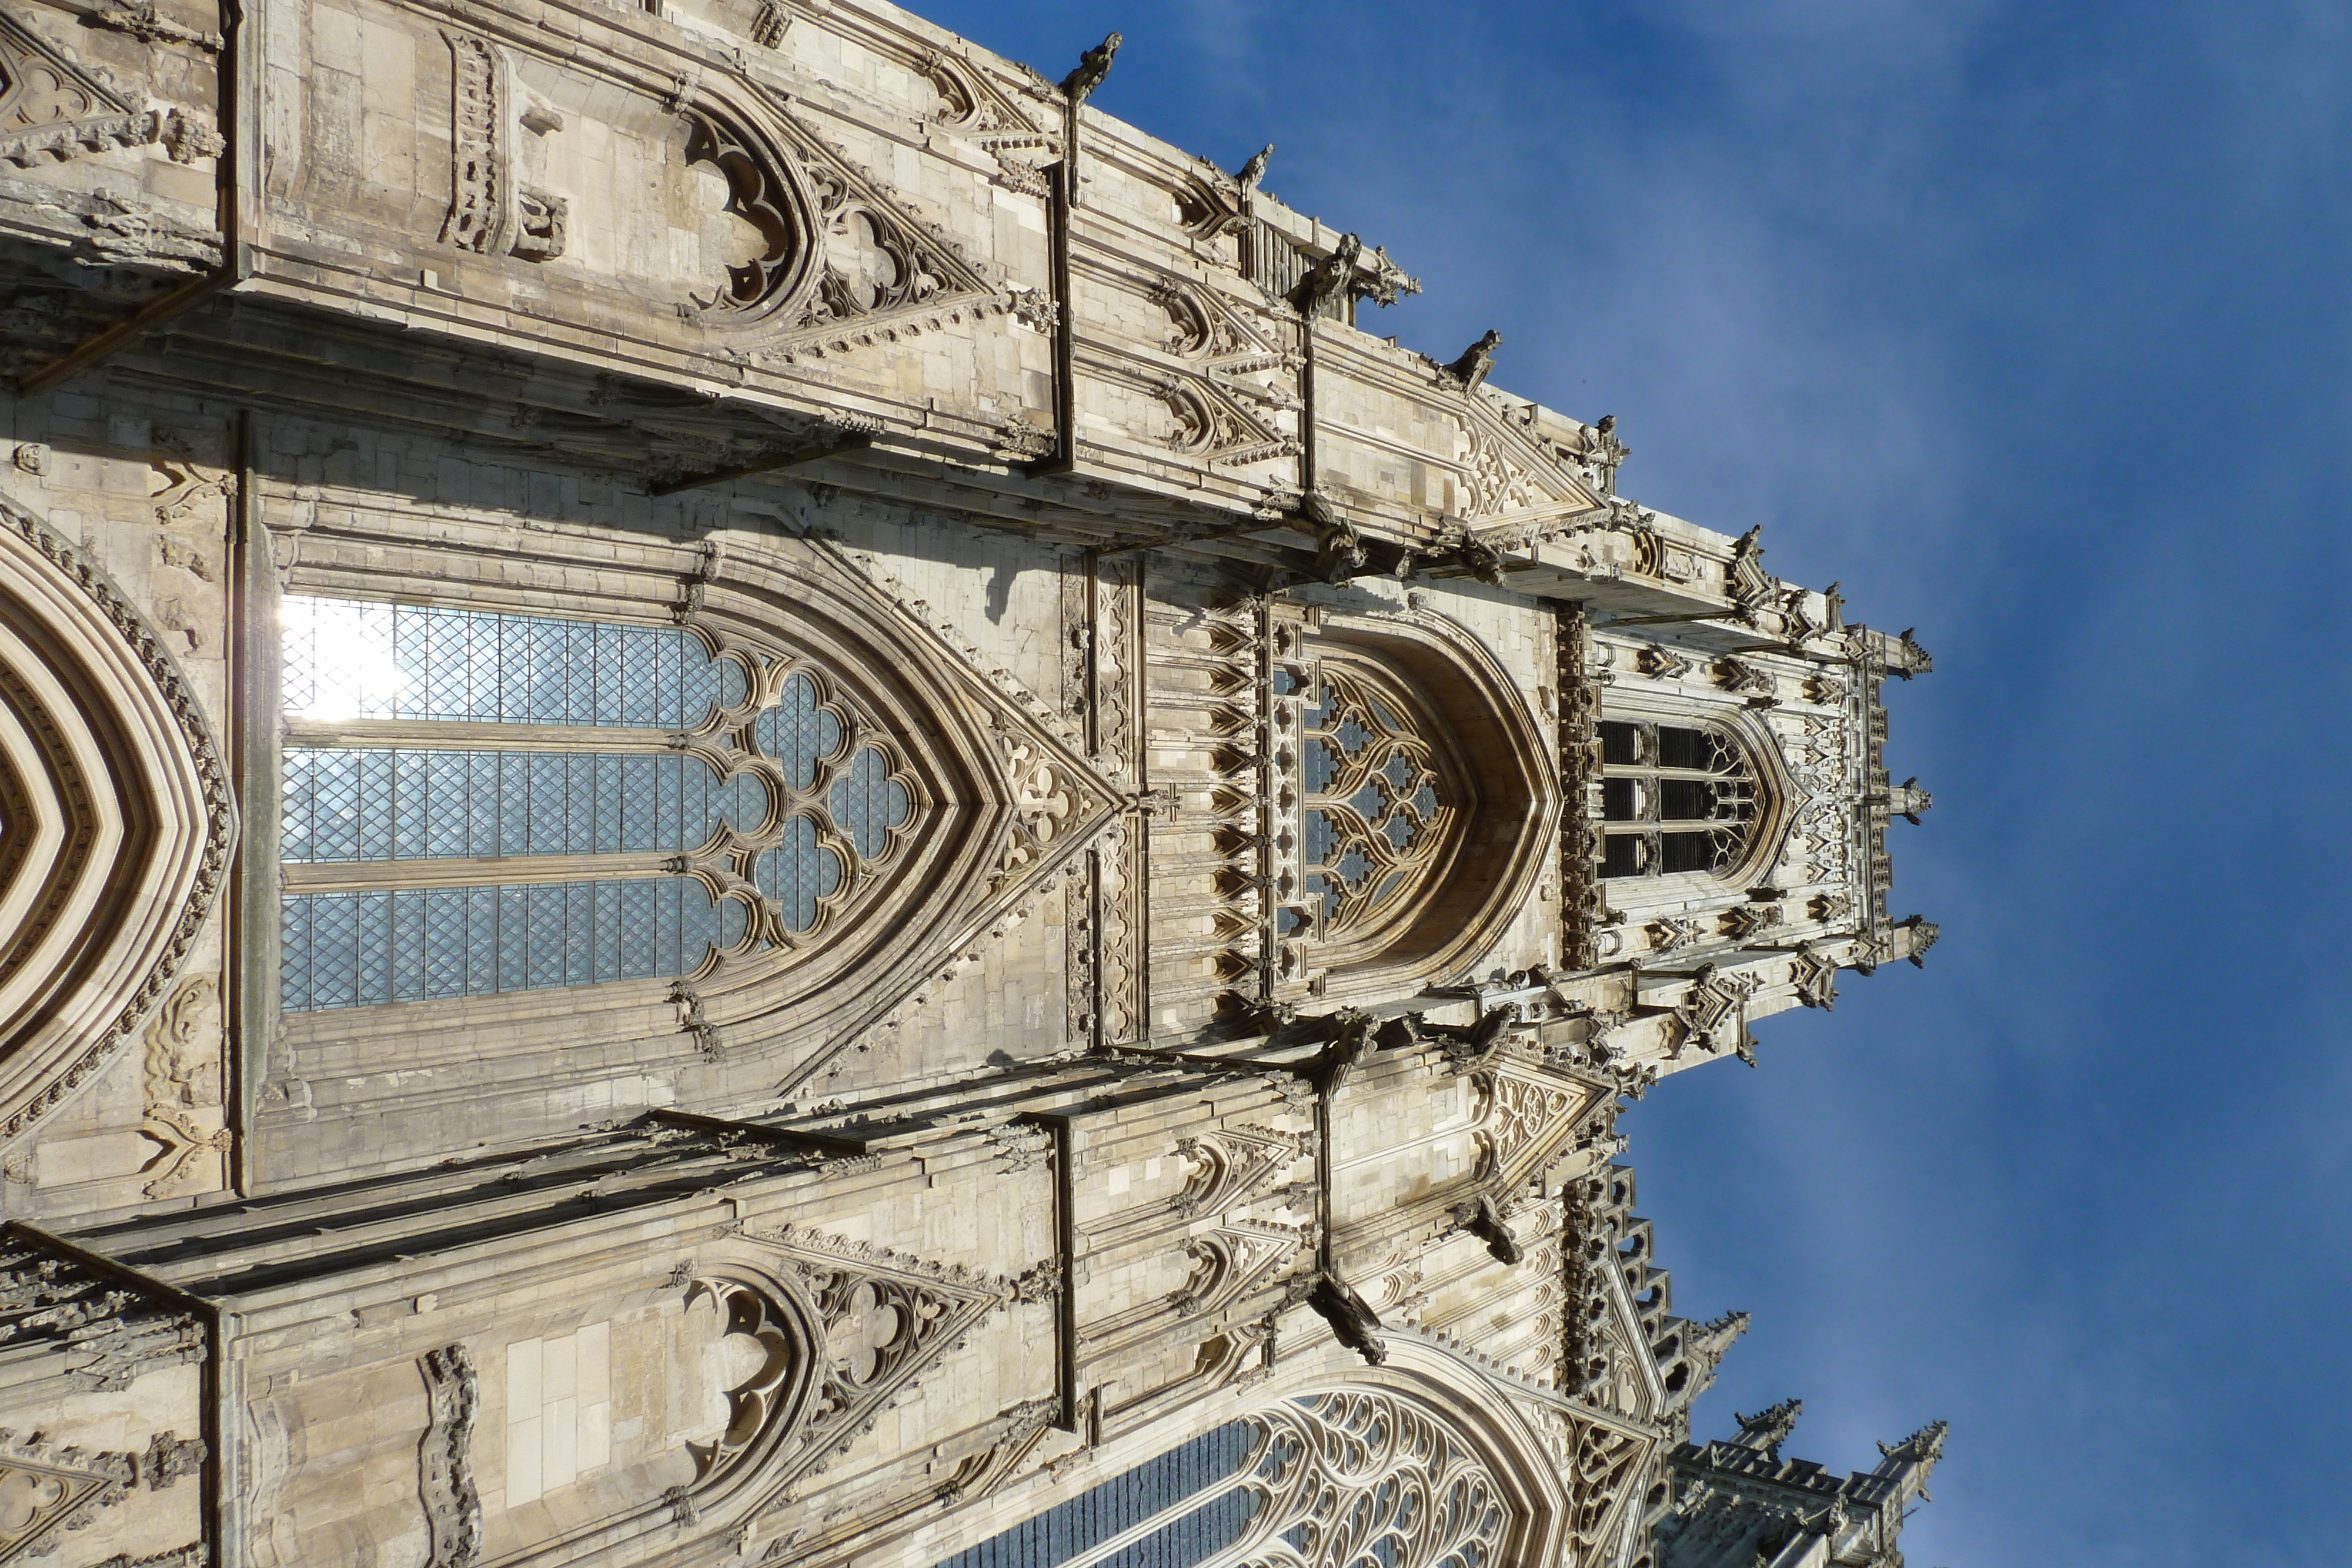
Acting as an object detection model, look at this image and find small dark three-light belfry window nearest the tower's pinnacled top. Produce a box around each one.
[1599,720,1757,877]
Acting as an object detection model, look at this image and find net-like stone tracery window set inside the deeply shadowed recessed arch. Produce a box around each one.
[1301,658,1454,940]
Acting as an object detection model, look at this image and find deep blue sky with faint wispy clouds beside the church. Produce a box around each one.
[922,0,2352,1568]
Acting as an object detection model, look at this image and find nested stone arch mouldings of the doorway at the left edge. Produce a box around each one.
[0,499,238,1140]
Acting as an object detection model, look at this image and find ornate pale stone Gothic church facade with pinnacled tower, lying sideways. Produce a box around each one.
[0,0,1943,1568]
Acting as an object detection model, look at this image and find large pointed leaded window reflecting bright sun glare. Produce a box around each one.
[280,597,922,1013]
